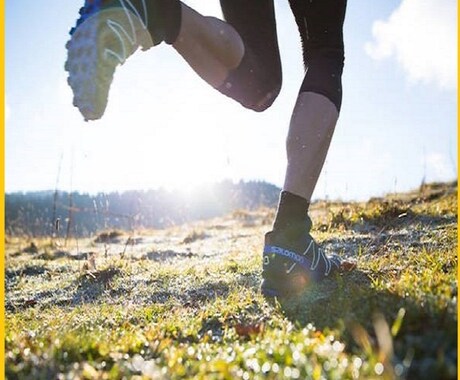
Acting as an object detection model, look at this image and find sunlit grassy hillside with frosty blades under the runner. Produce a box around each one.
[5,183,457,379]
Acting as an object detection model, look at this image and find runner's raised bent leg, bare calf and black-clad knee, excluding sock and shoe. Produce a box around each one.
[173,0,281,111]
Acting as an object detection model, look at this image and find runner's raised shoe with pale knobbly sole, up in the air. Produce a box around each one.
[65,0,162,121]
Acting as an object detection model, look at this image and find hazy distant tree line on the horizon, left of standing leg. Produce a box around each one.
[5,181,280,237]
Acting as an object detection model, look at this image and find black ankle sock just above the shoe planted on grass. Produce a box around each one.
[273,191,311,234]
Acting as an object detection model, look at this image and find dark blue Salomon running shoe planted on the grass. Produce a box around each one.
[261,229,341,297]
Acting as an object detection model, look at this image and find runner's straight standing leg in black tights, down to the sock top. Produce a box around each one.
[284,0,346,201]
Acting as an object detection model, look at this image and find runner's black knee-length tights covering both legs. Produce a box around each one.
[220,0,346,109]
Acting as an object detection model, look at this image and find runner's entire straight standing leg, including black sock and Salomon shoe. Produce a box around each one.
[261,0,346,296]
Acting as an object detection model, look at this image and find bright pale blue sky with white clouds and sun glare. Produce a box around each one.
[5,0,457,199]
